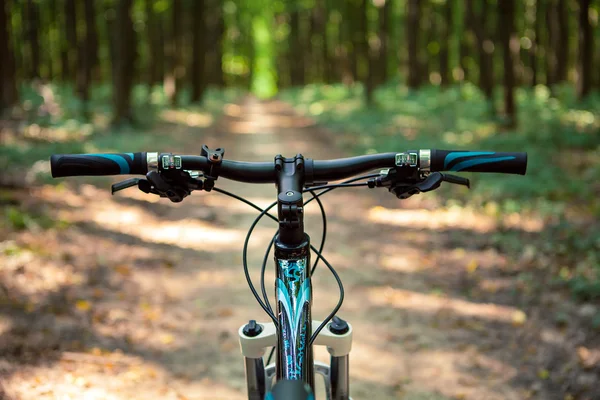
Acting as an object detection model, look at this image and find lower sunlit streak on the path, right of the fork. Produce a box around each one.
[367,286,521,323]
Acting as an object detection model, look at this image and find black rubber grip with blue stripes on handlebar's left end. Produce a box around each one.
[50,152,148,178]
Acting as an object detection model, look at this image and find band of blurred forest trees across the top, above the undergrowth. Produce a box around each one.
[0,0,600,127]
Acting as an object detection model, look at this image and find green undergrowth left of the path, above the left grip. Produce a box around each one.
[0,84,242,182]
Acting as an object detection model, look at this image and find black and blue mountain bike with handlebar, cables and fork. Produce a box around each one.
[50,145,527,400]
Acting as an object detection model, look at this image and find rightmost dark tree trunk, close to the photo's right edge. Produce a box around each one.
[577,0,594,100]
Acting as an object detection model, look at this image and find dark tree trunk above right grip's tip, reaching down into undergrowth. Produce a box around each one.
[498,0,519,128]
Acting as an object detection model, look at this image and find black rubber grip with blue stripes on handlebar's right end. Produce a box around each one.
[431,150,527,175]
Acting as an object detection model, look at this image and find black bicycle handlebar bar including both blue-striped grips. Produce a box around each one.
[50,149,527,183]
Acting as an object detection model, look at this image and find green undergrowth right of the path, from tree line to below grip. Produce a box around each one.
[280,83,600,301]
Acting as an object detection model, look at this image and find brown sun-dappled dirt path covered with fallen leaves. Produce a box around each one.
[0,98,600,400]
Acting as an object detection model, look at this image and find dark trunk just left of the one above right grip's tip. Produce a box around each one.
[466,0,494,104]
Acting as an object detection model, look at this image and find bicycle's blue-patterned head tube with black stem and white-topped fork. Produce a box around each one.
[239,155,352,400]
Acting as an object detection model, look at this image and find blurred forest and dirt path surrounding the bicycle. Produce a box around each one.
[0,0,600,400]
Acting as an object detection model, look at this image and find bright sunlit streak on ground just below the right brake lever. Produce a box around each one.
[367,206,544,233]
